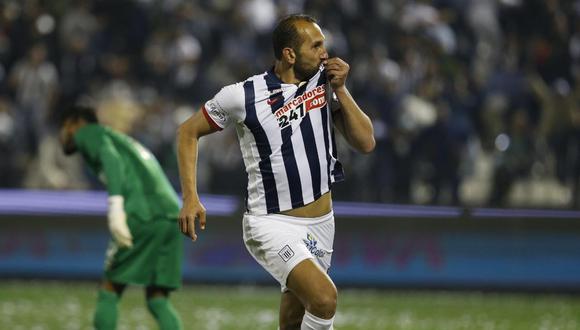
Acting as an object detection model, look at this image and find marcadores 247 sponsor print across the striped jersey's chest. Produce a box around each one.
[274,85,326,128]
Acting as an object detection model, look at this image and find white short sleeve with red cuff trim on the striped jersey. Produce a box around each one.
[202,83,245,130]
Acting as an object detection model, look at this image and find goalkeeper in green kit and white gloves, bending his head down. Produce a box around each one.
[60,106,183,330]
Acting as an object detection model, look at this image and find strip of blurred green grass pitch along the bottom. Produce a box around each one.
[0,280,580,330]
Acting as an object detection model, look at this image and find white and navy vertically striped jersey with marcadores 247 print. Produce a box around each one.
[202,66,344,214]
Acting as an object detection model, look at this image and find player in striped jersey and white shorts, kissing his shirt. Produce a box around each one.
[178,15,375,329]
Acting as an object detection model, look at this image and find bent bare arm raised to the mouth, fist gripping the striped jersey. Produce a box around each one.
[324,57,375,153]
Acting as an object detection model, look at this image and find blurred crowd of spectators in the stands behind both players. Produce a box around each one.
[0,0,580,208]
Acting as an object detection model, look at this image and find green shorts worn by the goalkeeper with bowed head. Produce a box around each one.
[105,219,183,289]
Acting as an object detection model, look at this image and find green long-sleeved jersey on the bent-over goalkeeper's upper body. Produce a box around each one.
[74,124,179,222]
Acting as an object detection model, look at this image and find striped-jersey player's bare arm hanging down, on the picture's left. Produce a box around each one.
[177,109,218,241]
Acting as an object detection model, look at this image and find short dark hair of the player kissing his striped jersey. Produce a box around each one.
[272,14,318,60]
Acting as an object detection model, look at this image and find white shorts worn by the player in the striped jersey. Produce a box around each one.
[242,211,334,291]
